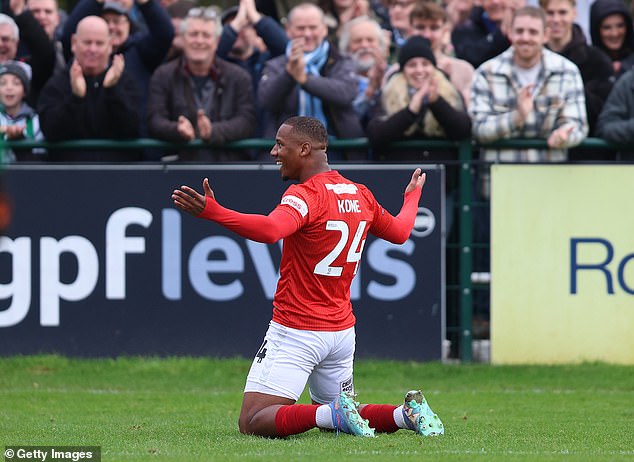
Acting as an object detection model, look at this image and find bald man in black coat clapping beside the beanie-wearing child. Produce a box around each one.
[38,16,141,162]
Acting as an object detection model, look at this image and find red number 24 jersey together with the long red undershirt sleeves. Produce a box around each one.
[199,171,421,331]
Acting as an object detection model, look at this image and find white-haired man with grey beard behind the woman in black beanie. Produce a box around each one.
[339,16,389,127]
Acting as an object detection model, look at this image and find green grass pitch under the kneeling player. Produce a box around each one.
[0,356,634,462]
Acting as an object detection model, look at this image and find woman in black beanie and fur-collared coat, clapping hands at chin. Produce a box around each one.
[367,36,471,160]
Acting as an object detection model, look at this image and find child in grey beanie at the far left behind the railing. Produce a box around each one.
[0,61,44,162]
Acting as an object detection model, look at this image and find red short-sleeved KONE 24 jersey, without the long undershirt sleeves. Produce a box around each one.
[273,171,400,331]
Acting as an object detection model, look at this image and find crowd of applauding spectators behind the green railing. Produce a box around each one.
[0,0,634,163]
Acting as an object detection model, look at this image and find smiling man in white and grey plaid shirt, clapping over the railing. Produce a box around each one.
[470,6,588,197]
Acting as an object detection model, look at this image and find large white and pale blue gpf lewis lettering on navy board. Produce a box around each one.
[0,207,430,327]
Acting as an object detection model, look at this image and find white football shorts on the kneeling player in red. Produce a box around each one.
[244,321,355,404]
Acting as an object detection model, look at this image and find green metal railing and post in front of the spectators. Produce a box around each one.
[0,138,634,362]
